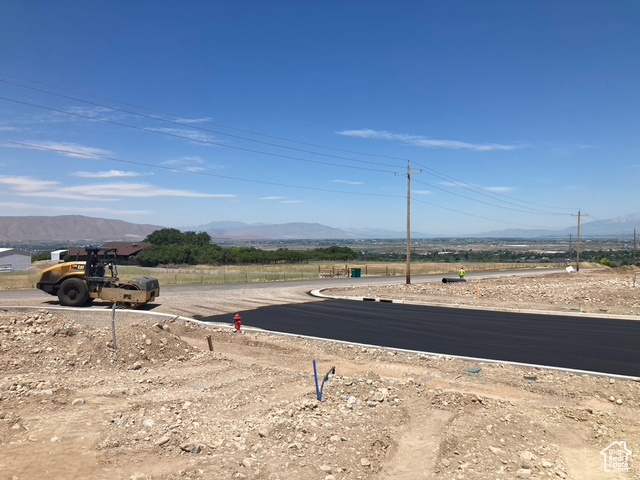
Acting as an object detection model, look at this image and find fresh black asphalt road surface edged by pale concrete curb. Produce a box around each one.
[202,300,640,377]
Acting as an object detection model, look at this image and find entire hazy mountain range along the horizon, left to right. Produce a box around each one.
[0,213,640,246]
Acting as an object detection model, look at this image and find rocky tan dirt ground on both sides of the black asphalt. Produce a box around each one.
[0,269,640,480]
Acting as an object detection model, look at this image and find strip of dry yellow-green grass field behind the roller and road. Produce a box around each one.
[0,262,564,290]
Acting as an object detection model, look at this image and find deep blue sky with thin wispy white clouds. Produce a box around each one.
[0,0,640,235]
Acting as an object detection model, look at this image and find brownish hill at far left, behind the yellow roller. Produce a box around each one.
[0,215,163,245]
